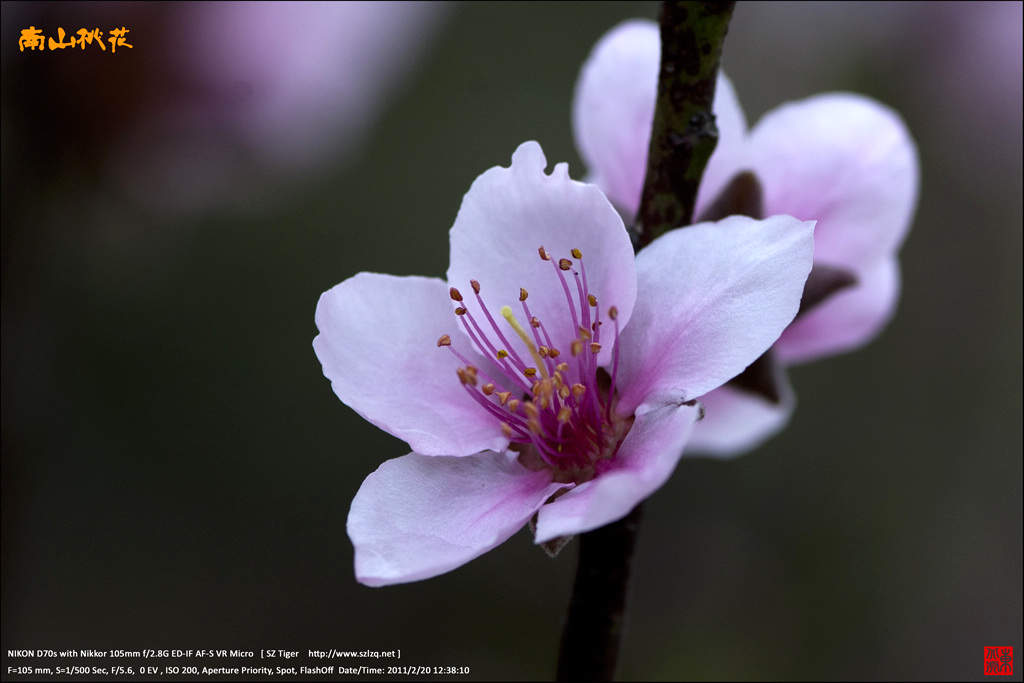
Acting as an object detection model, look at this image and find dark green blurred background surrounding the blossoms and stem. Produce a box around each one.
[0,2,1024,680]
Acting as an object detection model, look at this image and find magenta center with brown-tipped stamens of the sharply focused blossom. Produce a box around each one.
[437,247,633,483]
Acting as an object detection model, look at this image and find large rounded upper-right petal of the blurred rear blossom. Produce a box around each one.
[750,93,920,271]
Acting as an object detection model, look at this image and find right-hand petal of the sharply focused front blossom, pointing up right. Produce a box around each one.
[616,216,814,415]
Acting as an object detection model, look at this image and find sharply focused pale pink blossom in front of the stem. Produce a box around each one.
[313,142,813,586]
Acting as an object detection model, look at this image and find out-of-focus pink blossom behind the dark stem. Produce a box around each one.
[573,20,919,455]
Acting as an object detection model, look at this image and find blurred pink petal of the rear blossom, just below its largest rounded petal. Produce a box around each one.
[775,257,900,365]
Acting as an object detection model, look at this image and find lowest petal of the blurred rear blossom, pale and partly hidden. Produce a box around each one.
[684,366,797,458]
